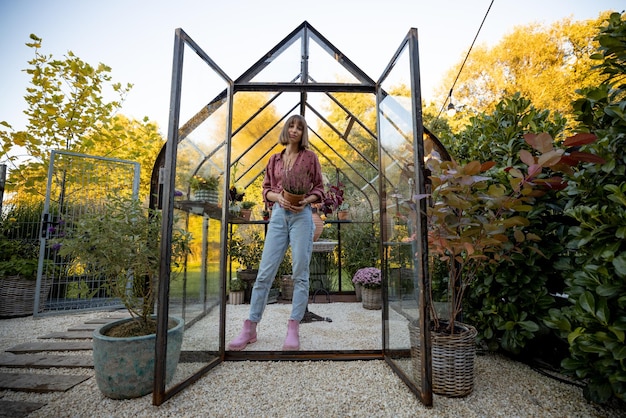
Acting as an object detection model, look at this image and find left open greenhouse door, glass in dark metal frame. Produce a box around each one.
[153,29,233,405]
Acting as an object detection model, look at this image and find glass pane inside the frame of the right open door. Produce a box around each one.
[378,38,422,398]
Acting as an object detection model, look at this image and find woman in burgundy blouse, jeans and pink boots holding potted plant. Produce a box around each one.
[228,115,324,351]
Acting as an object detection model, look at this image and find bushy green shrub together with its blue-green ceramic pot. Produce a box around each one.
[52,196,191,399]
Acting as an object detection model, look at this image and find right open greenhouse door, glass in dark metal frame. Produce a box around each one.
[377,29,432,406]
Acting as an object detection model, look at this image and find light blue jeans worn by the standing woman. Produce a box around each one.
[248,204,315,322]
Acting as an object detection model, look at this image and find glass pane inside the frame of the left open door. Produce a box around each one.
[166,36,229,389]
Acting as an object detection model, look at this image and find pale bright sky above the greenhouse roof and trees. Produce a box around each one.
[0,0,626,137]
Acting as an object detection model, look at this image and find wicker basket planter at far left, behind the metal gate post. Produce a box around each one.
[0,276,52,317]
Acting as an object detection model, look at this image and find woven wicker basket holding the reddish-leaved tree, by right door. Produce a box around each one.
[409,322,477,398]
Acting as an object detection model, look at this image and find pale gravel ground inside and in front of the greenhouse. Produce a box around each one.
[0,303,626,417]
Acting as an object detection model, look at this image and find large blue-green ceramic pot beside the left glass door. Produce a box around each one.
[93,316,185,399]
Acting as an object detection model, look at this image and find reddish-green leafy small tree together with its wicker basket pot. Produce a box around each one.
[409,134,595,396]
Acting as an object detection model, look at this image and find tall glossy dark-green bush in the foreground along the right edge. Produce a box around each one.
[546,13,626,403]
